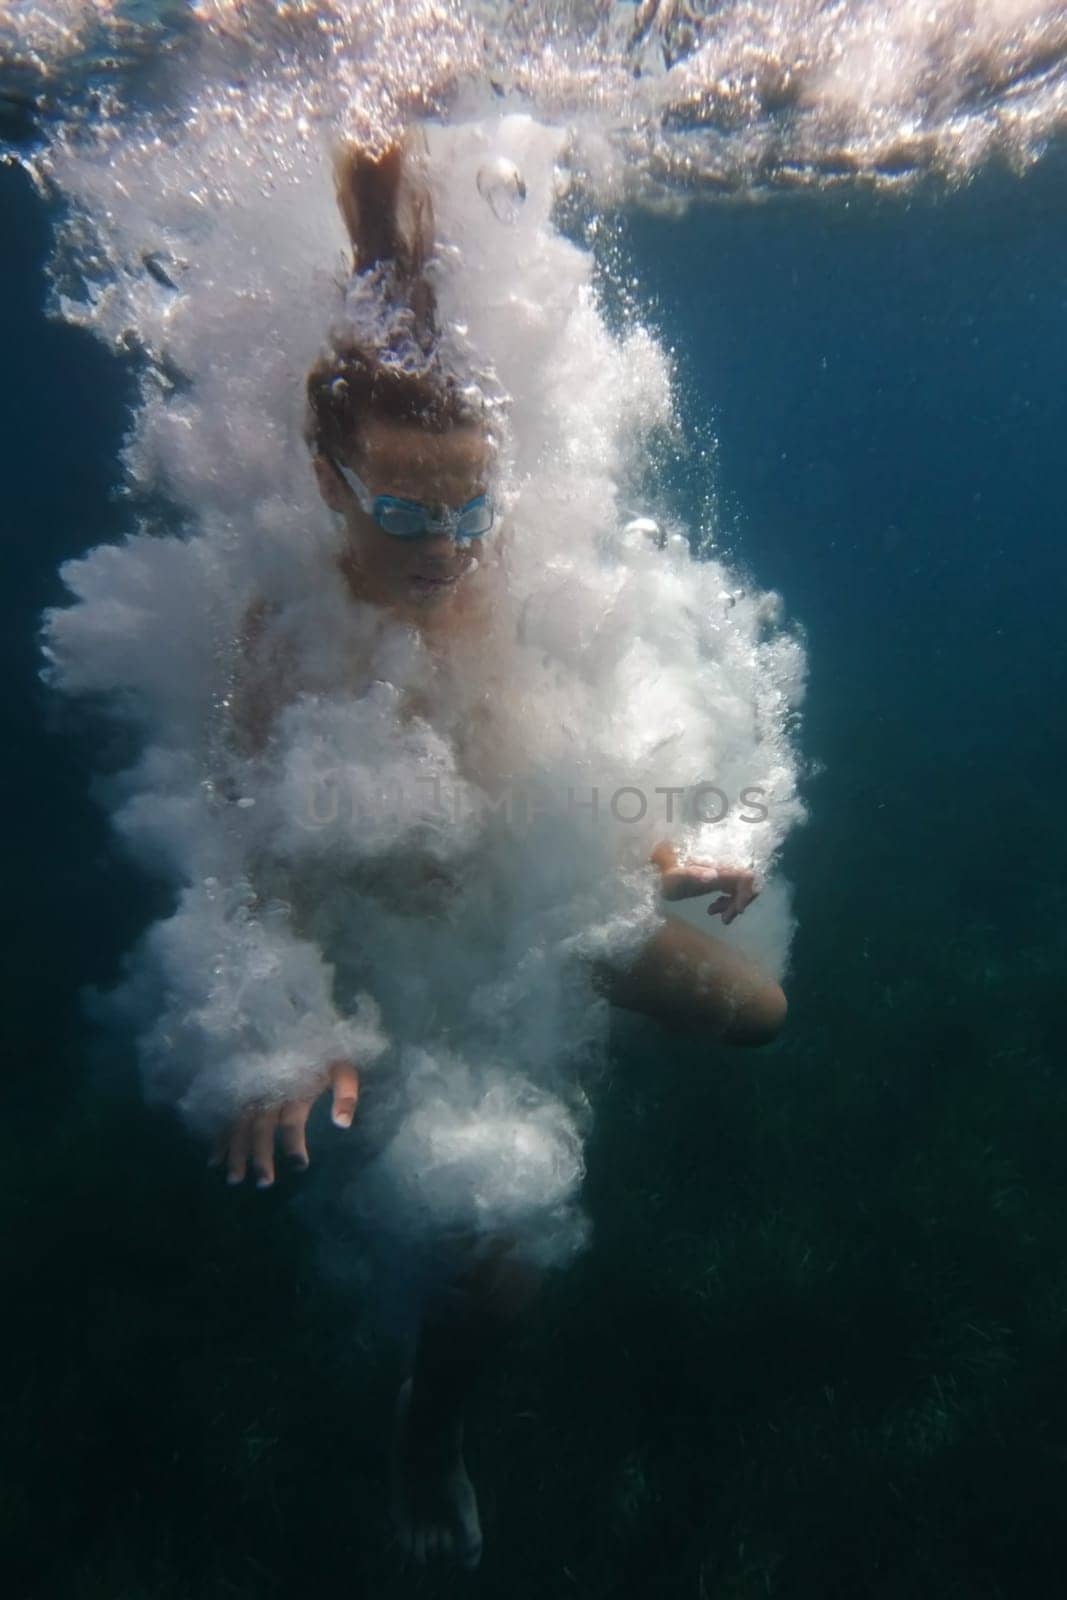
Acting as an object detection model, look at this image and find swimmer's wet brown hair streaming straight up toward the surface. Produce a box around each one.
[306,139,485,459]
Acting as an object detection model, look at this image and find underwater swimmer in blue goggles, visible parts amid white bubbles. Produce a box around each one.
[213,137,785,1566]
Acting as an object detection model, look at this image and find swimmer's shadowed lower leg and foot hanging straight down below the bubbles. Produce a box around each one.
[392,1238,541,1568]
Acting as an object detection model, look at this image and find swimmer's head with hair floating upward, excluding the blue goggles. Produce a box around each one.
[307,142,493,613]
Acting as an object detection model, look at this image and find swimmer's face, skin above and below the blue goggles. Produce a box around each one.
[315,421,493,613]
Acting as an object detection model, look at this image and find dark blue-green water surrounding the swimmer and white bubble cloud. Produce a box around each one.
[0,155,1067,1600]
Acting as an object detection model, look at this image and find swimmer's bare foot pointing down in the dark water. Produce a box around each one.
[390,1378,482,1568]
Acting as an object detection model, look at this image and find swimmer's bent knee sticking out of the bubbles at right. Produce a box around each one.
[593,915,787,1045]
